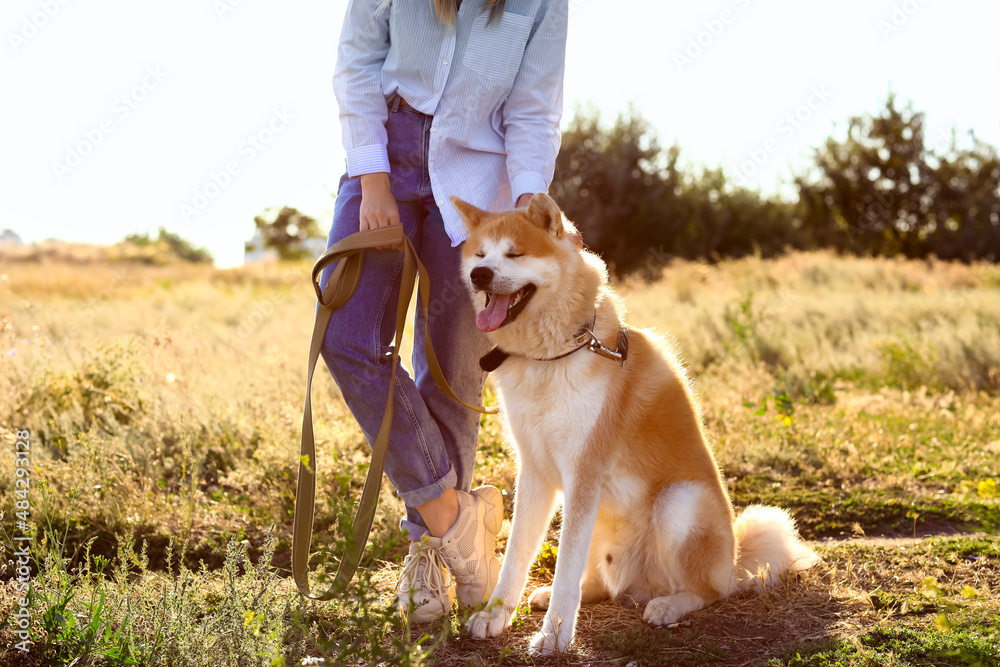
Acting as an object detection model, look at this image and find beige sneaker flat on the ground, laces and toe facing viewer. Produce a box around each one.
[396,535,455,623]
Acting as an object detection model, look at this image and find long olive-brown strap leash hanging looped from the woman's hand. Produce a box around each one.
[292,225,497,600]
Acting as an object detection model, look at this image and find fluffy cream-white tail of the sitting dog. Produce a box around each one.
[730,505,819,593]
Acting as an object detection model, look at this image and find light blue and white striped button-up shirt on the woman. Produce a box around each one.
[333,0,569,245]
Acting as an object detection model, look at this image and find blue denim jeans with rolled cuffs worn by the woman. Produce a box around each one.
[320,100,489,539]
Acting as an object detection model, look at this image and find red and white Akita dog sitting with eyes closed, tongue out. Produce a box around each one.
[452,193,818,655]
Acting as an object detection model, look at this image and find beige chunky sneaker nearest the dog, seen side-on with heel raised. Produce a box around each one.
[431,486,503,607]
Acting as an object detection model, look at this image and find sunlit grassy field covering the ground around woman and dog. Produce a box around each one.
[0,253,1000,667]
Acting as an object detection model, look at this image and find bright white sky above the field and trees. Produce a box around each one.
[0,0,1000,267]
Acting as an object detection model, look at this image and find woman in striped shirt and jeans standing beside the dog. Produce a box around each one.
[322,0,568,622]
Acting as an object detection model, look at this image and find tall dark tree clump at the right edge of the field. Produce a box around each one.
[797,94,1000,260]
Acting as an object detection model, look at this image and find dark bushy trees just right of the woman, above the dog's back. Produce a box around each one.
[550,110,803,277]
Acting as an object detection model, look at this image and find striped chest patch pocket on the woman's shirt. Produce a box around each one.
[462,12,534,81]
